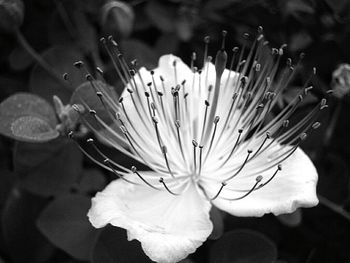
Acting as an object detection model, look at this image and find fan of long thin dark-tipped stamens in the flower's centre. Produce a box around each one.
[65,28,327,200]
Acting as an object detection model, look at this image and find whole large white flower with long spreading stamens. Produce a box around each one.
[70,32,327,262]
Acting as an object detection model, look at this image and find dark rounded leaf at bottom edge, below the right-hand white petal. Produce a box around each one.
[210,230,277,263]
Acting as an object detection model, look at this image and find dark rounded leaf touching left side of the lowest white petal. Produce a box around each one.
[37,194,99,260]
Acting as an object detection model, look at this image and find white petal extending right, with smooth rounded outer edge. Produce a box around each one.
[209,148,318,216]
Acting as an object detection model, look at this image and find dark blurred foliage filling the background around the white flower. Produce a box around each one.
[0,0,350,263]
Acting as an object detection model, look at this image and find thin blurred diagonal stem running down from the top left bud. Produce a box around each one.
[16,30,69,89]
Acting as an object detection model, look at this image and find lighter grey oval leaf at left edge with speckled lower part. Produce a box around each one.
[0,93,59,142]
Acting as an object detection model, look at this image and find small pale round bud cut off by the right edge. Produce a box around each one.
[332,64,350,99]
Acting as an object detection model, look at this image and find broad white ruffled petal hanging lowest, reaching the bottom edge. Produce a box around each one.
[88,175,212,263]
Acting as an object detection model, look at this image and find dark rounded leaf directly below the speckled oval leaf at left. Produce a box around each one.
[14,140,82,196]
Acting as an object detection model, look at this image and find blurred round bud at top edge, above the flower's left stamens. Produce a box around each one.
[101,0,135,37]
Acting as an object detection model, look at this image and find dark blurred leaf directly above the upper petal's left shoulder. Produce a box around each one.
[122,39,158,69]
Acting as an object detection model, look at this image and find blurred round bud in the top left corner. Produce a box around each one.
[0,0,24,32]
